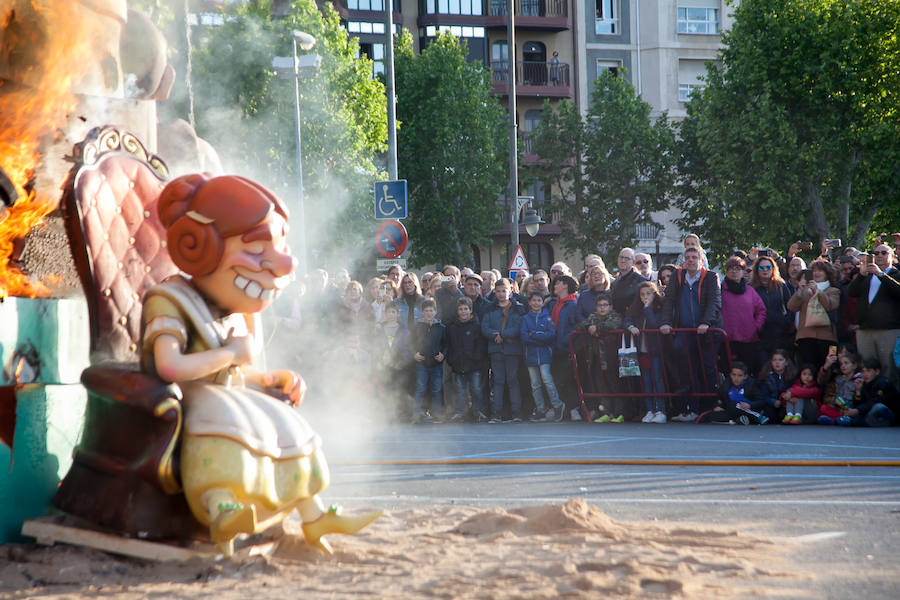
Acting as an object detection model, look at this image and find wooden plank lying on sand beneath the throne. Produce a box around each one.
[22,517,278,561]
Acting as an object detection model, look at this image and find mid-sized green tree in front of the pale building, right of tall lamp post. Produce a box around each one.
[532,72,675,262]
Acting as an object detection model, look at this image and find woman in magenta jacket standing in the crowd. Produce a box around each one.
[722,256,766,376]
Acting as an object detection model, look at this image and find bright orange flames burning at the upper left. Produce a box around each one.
[0,0,103,299]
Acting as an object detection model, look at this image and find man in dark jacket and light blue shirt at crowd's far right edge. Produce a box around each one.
[847,244,900,384]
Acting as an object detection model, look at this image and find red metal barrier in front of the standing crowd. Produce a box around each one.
[569,328,731,422]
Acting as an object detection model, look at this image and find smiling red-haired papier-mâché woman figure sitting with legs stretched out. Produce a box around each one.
[141,175,380,555]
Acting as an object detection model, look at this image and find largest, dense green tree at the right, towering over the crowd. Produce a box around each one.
[678,0,900,257]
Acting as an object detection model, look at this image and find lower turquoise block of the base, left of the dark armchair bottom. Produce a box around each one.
[0,384,87,544]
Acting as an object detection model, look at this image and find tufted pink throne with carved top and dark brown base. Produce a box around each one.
[54,127,204,538]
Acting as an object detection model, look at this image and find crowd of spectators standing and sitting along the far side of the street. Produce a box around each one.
[276,234,900,426]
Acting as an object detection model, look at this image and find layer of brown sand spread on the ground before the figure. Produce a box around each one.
[0,499,812,600]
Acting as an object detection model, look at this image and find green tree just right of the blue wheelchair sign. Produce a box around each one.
[395,31,506,265]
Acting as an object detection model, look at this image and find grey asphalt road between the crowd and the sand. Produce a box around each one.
[316,421,900,599]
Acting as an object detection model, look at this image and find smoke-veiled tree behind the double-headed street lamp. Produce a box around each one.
[180,0,387,264]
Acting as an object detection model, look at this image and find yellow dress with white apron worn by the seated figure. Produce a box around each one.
[141,275,329,533]
